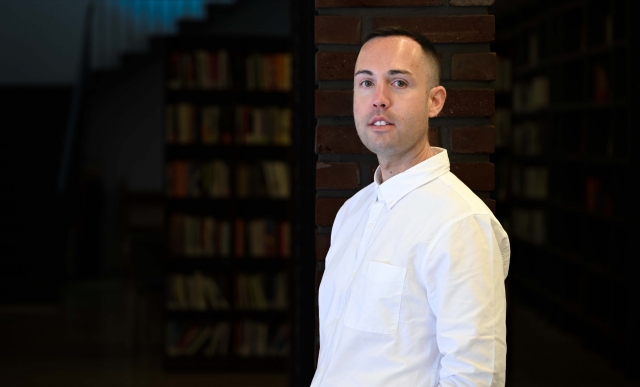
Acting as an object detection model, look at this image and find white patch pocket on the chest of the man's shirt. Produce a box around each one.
[344,261,407,334]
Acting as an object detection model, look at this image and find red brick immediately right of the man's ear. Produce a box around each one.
[438,89,495,117]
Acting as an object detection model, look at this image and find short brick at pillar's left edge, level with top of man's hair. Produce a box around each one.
[315,16,362,44]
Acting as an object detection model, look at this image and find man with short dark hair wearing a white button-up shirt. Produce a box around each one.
[311,28,510,387]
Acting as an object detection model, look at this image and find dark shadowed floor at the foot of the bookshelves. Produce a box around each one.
[0,280,638,387]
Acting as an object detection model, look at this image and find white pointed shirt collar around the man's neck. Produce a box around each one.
[373,147,449,208]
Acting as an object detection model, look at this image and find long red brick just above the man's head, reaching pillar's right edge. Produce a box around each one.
[373,15,495,43]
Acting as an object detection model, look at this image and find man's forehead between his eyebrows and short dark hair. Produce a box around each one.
[356,36,428,75]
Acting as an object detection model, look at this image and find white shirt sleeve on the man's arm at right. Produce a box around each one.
[424,214,507,387]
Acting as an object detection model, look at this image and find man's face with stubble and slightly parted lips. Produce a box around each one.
[353,36,433,158]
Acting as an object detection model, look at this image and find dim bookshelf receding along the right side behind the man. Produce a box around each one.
[496,0,638,370]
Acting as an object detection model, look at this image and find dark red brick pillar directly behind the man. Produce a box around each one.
[315,0,496,364]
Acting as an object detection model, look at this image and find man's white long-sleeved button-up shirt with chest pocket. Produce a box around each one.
[311,147,510,387]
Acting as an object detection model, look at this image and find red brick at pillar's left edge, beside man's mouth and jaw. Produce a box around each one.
[316,126,371,154]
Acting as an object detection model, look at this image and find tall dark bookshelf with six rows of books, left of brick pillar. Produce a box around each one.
[164,36,293,372]
